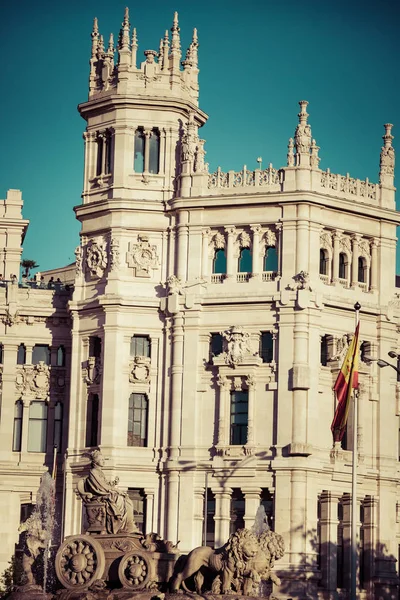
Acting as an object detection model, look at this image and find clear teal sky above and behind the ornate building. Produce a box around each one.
[0,0,400,270]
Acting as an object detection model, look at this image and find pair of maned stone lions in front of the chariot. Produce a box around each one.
[171,529,284,596]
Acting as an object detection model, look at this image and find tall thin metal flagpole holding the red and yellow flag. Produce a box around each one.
[350,302,361,600]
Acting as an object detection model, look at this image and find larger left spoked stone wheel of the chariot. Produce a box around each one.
[55,535,105,590]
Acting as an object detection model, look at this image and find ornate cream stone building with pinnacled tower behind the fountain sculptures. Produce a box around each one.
[0,12,400,599]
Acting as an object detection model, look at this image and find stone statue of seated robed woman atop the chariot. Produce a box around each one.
[77,450,139,533]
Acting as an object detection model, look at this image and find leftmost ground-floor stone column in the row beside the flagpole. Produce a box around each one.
[320,490,339,594]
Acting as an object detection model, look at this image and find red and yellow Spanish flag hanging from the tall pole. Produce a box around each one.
[331,323,360,442]
